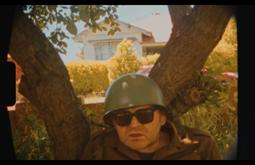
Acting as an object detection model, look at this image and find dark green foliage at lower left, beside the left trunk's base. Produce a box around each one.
[12,102,53,160]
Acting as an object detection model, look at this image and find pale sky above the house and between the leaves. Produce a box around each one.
[44,5,172,64]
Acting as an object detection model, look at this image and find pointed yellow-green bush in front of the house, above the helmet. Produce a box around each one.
[108,39,142,81]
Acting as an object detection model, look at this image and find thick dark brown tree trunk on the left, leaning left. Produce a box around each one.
[10,8,89,159]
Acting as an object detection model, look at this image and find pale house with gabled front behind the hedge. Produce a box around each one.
[74,20,166,60]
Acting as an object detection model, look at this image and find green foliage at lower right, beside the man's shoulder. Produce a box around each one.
[180,79,237,154]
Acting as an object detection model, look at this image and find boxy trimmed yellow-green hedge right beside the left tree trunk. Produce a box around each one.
[67,60,109,95]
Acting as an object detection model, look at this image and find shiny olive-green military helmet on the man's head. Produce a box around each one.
[104,73,166,124]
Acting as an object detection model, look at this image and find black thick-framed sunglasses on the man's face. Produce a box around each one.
[112,107,158,127]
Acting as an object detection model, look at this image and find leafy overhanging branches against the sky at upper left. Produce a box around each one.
[23,5,120,54]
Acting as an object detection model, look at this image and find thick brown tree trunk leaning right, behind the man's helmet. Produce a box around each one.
[149,5,233,118]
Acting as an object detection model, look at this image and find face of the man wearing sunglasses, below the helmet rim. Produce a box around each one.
[113,105,166,152]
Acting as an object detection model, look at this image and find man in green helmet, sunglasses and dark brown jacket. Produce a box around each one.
[81,73,220,160]
